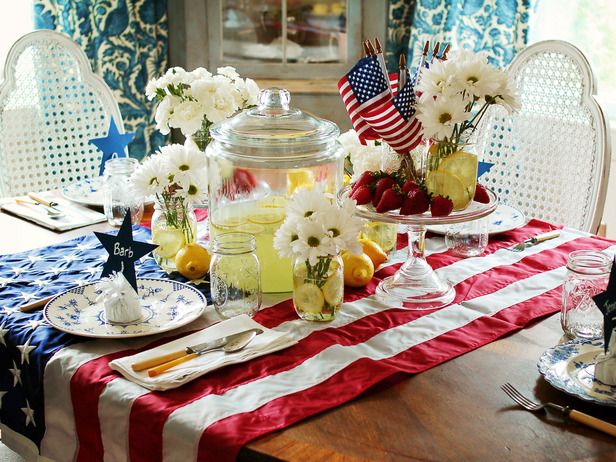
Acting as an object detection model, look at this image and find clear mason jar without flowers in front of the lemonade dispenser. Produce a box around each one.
[210,232,262,318]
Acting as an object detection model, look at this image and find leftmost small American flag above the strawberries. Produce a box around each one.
[338,56,391,142]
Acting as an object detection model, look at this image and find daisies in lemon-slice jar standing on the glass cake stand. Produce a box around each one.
[417,50,519,210]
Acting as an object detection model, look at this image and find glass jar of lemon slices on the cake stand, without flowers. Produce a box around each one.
[425,140,478,210]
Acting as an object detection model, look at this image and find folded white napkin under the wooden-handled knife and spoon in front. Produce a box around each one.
[109,315,297,390]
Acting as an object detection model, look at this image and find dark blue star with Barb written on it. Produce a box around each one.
[94,212,158,292]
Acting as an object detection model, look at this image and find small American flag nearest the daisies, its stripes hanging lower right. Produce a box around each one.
[361,71,423,154]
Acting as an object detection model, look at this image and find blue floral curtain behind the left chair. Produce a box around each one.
[34,0,168,158]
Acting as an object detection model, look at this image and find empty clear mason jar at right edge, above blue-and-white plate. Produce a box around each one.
[560,250,612,338]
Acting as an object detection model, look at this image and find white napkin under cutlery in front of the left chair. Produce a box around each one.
[0,191,106,231]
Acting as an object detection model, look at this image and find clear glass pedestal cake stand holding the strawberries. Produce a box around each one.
[338,186,498,310]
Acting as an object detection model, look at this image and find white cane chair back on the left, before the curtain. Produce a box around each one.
[0,30,124,197]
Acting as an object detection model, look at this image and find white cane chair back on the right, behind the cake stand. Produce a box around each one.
[477,40,611,232]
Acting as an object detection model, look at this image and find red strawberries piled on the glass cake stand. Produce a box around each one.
[350,171,490,217]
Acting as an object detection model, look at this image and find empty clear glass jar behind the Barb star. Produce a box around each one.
[103,157,143,226]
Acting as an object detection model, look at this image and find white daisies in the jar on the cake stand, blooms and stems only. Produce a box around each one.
[416,50,519,157]
